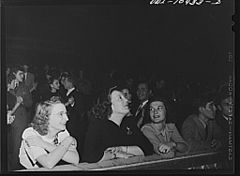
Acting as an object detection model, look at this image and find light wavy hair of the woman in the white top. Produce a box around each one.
[30,98,61,136]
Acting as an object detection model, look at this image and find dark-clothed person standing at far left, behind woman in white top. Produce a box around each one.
[9,66,33,170]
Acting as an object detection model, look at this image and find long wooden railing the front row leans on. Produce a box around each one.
[16,151,231,172]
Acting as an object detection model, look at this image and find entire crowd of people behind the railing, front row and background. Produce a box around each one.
[6,64,234,170]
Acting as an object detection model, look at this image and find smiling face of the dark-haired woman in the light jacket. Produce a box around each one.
[150,101,166,123]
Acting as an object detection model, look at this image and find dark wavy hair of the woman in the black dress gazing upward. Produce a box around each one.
[88,86,121,120]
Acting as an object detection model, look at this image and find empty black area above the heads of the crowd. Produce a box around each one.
[5,0,234,81]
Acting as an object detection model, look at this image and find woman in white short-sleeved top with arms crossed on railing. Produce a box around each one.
[19,98,79,168]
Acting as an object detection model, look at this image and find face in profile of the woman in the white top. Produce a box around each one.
[49,103,69,131]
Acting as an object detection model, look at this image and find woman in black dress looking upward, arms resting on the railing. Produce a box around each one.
[82,87,153,163]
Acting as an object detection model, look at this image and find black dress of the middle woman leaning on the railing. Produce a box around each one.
[82,119,153,163]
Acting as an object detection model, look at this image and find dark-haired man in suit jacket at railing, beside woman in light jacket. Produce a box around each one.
[182,92,222,152]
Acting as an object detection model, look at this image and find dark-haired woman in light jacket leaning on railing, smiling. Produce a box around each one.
[141,97,188,158]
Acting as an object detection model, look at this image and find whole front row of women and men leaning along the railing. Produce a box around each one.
[16,83,233,168]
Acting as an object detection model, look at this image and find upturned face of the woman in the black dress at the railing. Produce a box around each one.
[110,90,129,115]
